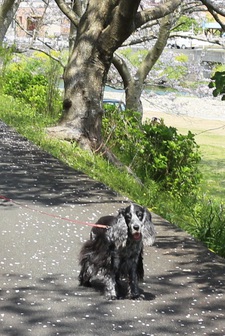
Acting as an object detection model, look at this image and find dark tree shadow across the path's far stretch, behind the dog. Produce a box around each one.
[0,122,124,206]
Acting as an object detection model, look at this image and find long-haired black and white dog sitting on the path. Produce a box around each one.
[79,204,155,299]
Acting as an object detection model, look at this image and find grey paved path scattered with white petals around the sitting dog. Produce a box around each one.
[0,122,225,336]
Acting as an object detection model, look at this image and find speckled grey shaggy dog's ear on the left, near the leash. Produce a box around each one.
[107,212,128,248]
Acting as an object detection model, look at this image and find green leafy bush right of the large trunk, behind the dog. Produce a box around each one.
[103,108,201,195]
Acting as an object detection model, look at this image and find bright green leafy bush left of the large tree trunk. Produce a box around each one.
[1,51,61,115]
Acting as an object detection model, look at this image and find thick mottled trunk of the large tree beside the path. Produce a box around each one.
[50,0,140,150]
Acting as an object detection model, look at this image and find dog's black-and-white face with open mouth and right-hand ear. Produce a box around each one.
[120,203,155,245]
